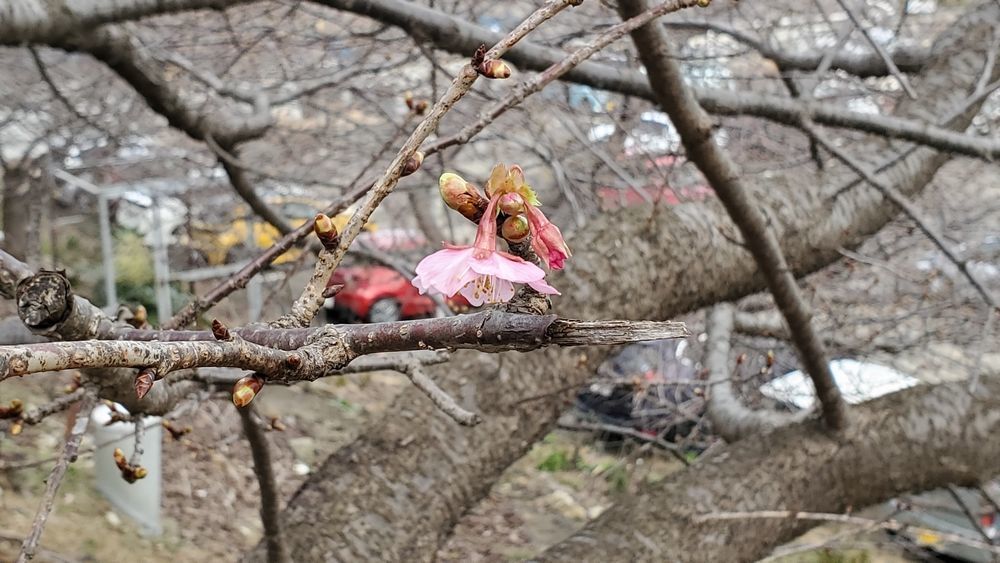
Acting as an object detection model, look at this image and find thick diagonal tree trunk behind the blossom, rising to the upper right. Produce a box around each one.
[251,5,1000,561]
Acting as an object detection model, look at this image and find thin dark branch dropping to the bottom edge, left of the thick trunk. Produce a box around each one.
[236,403,292,563]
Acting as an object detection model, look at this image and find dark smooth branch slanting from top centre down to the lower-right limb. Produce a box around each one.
[618,0,847,430]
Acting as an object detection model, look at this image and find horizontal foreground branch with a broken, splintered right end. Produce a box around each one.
[0,311,688,382]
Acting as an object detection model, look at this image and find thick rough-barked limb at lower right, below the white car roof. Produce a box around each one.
[541,378,1000,562]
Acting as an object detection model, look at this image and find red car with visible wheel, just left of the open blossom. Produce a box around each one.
[324,266,470,323]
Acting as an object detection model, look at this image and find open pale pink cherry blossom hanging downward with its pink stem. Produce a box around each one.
[412,197,559,307]
